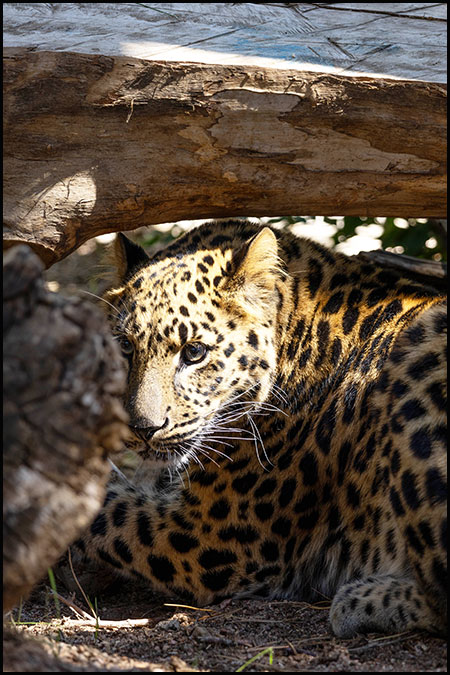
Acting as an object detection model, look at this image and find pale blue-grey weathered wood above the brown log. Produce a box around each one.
[3,2,447,86]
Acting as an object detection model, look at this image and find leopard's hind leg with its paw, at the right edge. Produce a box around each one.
[330,305,447,637]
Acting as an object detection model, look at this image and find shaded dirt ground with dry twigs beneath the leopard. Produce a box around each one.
[4,582,447,672]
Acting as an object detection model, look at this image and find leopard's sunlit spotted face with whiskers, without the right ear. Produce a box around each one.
[107,230,282,465]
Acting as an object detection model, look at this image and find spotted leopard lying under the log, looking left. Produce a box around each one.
[78,218,447,638]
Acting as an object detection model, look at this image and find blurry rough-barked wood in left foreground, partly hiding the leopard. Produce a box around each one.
[3,246,127,610]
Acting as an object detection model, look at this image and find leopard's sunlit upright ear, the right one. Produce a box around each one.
[228,227,283,318]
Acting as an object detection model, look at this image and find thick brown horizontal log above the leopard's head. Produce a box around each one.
[4,49,446,266]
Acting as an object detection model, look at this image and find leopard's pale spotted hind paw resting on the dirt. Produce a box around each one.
[330,575,440,638]
